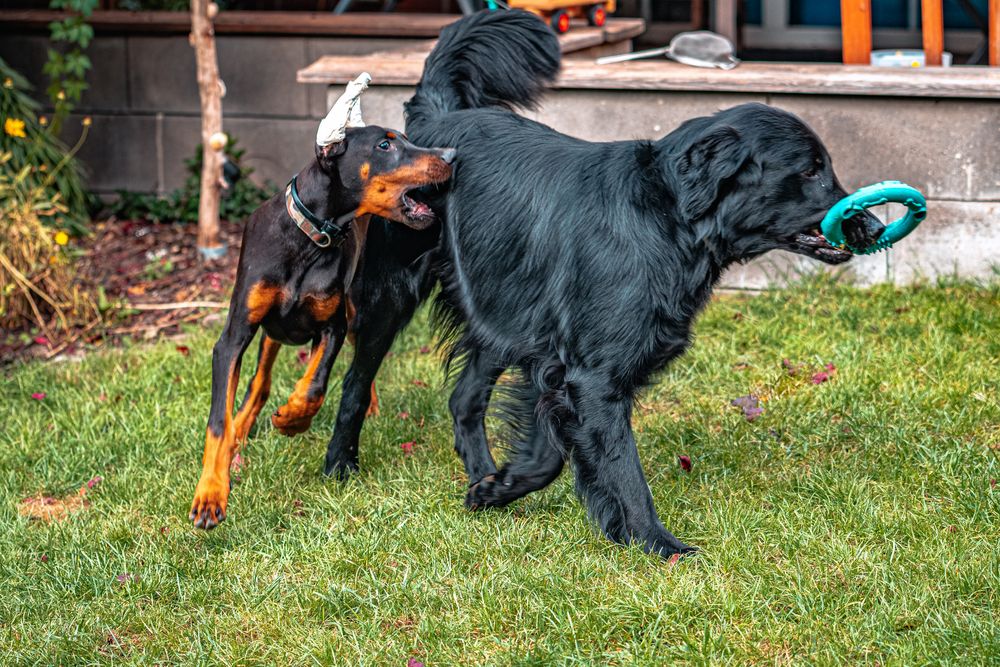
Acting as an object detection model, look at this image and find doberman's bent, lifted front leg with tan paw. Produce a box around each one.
[271,318,347,436]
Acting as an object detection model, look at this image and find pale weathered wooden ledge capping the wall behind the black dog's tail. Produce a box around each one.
[297,54,1000,99]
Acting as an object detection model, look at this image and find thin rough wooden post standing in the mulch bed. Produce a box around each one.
[191,0,225,258]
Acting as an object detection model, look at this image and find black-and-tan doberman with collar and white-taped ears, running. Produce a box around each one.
[190,79,455,529]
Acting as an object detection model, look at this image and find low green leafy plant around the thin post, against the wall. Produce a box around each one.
[111,137,277,223]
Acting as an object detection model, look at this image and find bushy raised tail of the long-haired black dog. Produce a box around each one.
[406,10,560,127]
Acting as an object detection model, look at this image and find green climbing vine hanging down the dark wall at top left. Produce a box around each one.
[42,0,97,134]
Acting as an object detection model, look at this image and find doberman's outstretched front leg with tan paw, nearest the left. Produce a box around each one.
[189,314,256,530]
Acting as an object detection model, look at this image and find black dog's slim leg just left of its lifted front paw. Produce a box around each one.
[448,350,504,490]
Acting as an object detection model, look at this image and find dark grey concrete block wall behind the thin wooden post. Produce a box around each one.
[0,33,426,195]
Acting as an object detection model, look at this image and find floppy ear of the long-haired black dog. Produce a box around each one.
[677,125,750,220]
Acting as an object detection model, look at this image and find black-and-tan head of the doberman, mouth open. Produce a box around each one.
[316,125,455,229]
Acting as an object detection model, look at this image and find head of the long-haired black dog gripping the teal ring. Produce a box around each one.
[661,104,885,264]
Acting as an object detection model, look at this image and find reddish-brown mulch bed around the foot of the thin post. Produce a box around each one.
[0,219,243,364]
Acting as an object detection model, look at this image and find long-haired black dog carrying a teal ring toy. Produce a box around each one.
[394,11,883,556]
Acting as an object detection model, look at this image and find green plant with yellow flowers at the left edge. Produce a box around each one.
[0,58,90,232]
